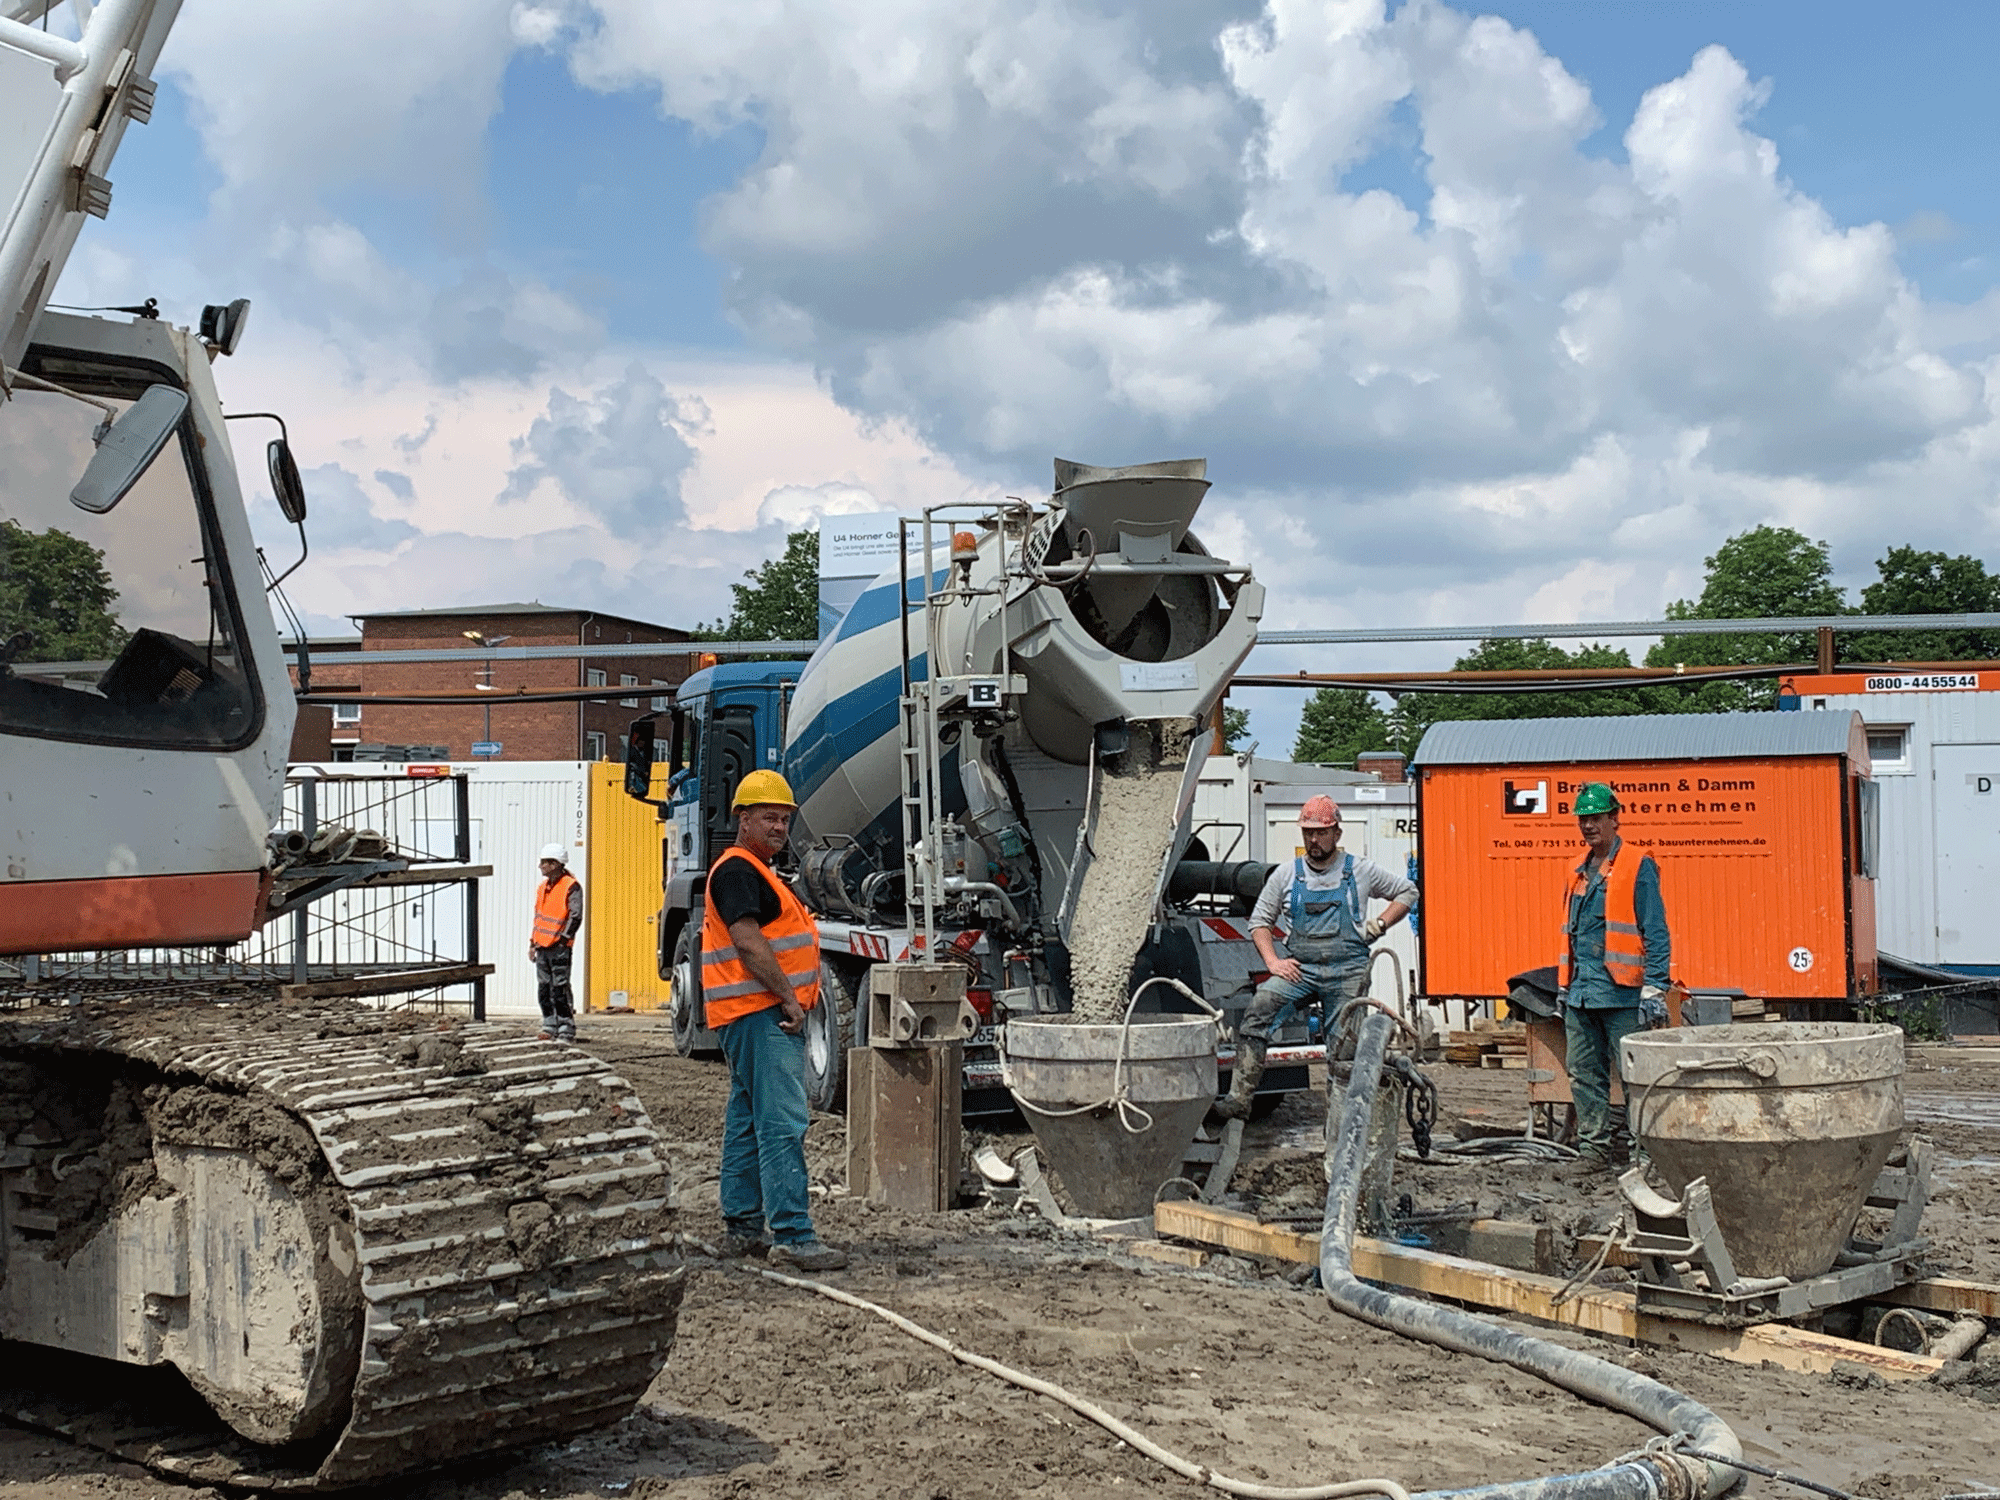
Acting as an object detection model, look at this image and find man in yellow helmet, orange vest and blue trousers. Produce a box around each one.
[702,770,848,1270]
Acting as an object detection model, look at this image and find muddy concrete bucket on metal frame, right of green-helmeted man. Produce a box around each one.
[1620,1022,1902,1280]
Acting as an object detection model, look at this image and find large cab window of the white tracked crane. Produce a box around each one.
[0,354,258,748]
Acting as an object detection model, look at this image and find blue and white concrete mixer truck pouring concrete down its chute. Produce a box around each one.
[628,460,1320,1114]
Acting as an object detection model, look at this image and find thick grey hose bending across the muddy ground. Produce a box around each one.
[1320,1012,1742,1500]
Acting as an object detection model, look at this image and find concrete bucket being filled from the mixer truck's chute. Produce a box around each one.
[1000,1016,1216,1218]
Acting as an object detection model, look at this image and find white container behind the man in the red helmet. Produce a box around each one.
[1194,754,1420,998]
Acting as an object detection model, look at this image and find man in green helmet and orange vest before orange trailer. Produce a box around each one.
[1556,782,1672,1174]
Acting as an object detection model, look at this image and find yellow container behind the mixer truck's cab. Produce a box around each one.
[580,762,668,1010]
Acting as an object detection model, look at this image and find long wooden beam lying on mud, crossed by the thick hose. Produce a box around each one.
[1152,1202,1944,1380]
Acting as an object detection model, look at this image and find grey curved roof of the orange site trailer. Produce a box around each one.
[1412,710,1868,766]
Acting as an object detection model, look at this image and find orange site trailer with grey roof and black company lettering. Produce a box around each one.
[1412,712,1880,1002]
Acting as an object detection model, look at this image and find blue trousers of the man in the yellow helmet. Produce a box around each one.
[716,1006,816,1244]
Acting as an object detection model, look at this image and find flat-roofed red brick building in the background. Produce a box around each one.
[328,604,694,760]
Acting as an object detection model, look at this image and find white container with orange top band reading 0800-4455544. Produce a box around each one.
[1780,672,2000,974]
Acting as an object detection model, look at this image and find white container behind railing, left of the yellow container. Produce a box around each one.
[292,760,590,1016]
